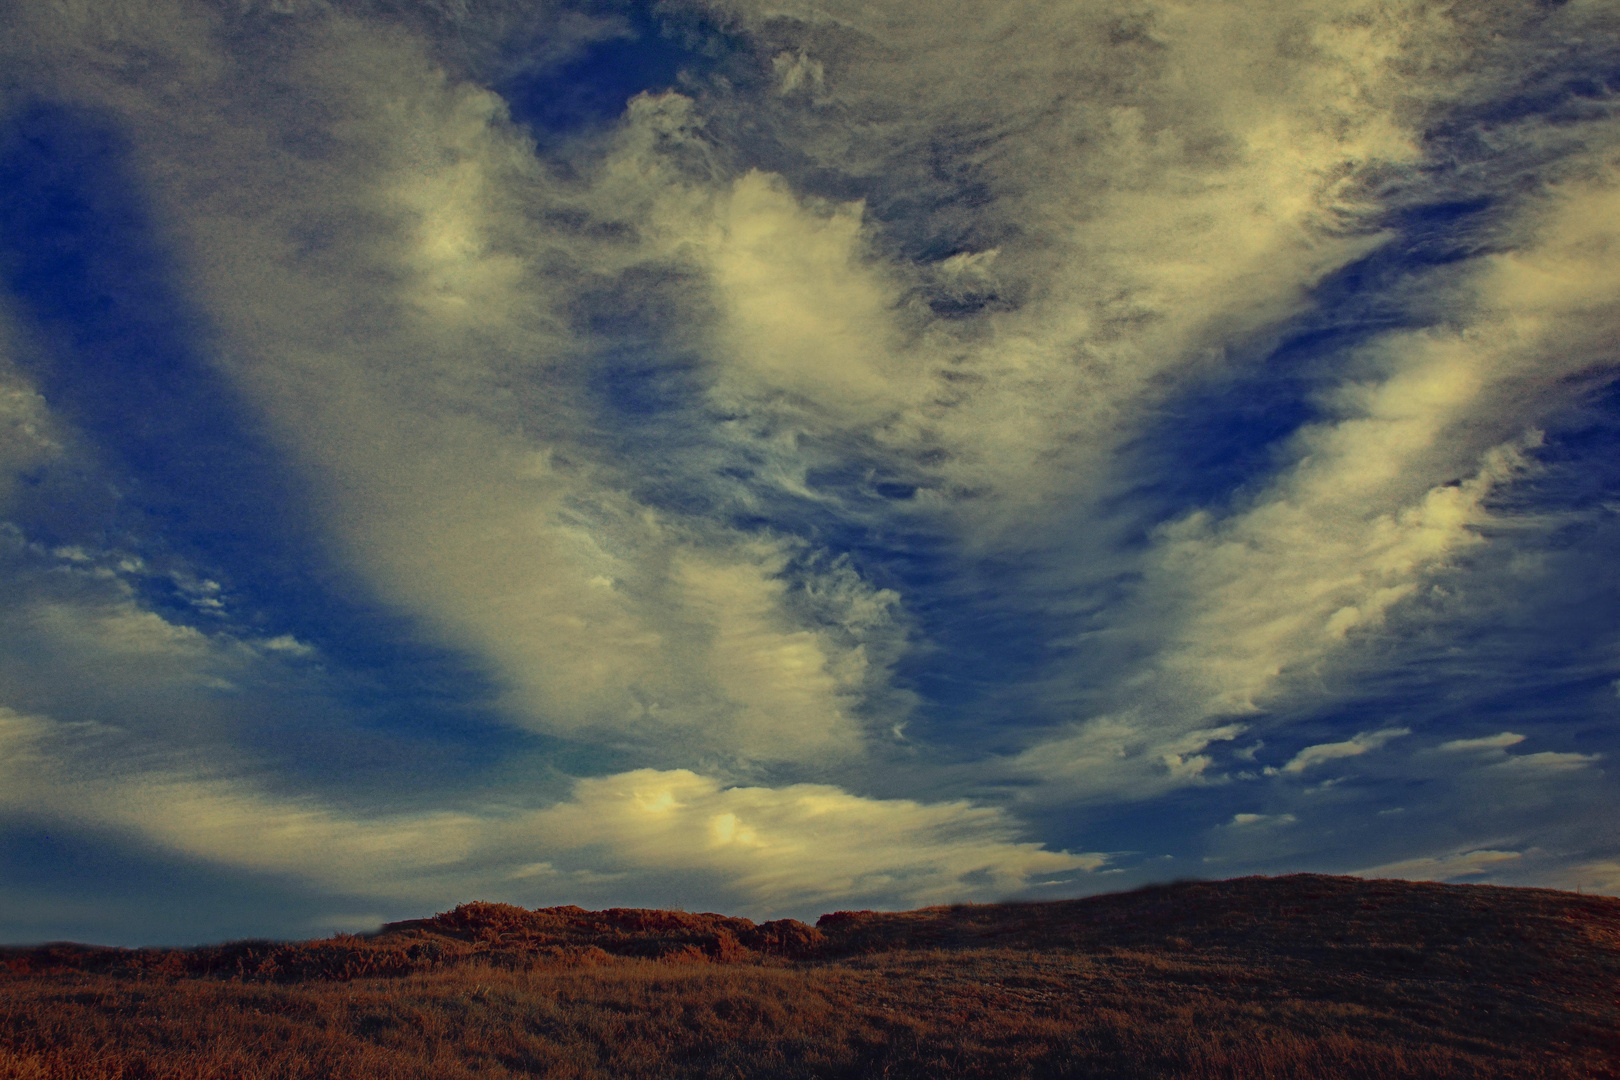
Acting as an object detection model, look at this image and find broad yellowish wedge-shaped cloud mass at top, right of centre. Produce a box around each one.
[664,0,1443,524]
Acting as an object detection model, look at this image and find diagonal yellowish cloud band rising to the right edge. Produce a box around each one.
[1010,105,1620,803]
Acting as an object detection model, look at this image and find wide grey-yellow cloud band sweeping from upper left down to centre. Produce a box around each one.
[0,13,904,764]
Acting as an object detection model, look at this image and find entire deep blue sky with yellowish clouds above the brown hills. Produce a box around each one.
[0,0,1620,944]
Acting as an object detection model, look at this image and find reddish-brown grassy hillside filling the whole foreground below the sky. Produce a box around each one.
[0,874,1620,1080]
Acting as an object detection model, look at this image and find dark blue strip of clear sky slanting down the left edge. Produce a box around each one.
[0,105,313,615]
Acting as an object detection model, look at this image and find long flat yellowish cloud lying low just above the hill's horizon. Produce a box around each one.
[0,709,1105,913]
